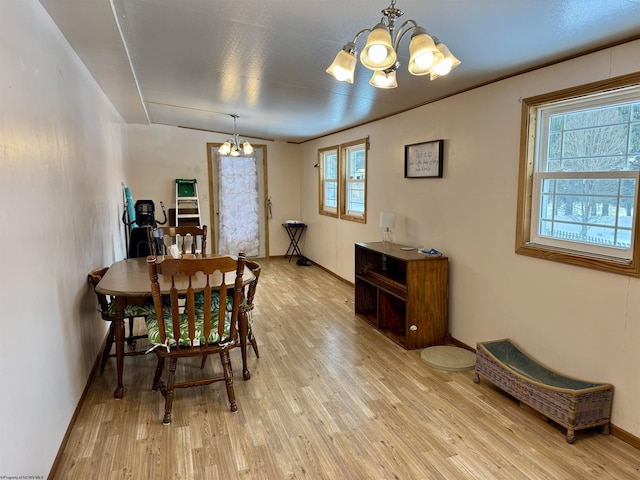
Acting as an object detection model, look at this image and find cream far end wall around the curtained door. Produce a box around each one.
[128,124,300,255]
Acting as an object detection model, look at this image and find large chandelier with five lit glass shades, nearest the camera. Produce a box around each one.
[326,0,460,88]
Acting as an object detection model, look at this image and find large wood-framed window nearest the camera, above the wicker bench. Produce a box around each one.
[516,74,640,276]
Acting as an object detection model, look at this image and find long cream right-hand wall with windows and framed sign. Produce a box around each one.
[300,41,640,436]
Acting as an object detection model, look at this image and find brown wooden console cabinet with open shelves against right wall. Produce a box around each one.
[355,242,449,350]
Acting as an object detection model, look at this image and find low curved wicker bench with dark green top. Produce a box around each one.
[474,339,613,443]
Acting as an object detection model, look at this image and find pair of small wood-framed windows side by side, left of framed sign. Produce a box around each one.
[317,138,368,223]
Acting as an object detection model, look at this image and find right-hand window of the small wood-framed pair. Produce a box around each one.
[340,139,367,223]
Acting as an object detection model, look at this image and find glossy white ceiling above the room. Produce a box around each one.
[40,0,640,143]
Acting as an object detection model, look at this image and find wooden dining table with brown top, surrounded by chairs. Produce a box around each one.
[96,255,255,398]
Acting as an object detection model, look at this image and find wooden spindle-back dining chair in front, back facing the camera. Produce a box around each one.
[147,253,245,425]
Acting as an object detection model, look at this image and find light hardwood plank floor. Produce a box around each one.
[52,258,640,480]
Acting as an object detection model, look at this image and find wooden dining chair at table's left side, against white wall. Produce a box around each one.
[88,267,152,373]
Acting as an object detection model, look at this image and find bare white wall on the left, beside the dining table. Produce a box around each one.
[0,0,126,472]
